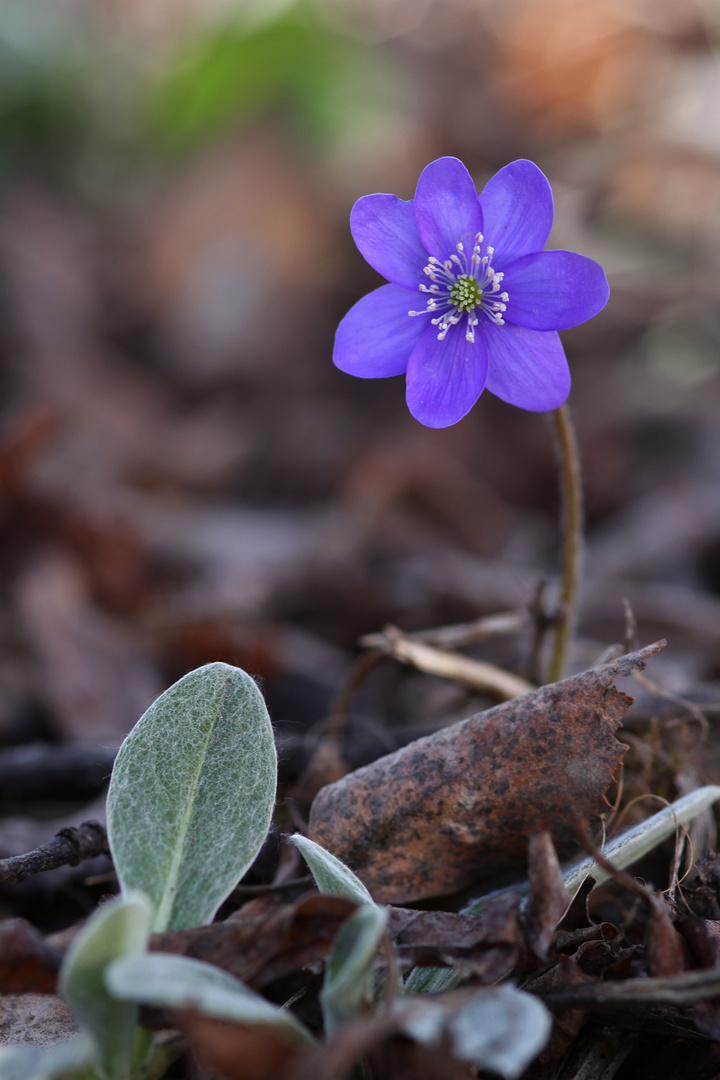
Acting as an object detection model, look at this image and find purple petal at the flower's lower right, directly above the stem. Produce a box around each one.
[481,321,570,413]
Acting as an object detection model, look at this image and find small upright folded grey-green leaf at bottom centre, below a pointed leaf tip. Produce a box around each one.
[320,904,388,1035]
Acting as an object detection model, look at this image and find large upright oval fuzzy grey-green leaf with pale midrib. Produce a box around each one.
[108,663,277,930]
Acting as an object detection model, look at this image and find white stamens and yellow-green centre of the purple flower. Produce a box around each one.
[408,232,510,341]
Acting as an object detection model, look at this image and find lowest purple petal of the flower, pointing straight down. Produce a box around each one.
[406,321,488,428]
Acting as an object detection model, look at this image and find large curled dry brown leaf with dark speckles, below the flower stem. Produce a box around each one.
[310,643,663,903]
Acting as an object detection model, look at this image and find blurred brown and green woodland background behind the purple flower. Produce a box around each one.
[0,0,720,876]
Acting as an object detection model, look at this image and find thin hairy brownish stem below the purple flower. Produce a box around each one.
[549,405,584,683]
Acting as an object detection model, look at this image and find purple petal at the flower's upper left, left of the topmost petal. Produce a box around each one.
[350,194,427,289]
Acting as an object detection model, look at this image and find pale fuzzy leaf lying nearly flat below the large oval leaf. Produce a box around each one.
[106,953,313,1042]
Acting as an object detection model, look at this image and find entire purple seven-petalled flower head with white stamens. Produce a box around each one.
[332,158,609,428]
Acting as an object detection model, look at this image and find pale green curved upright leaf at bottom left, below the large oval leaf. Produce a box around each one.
[59,892,152,1080]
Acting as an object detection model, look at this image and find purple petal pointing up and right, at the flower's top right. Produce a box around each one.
[480,158,555,270]
